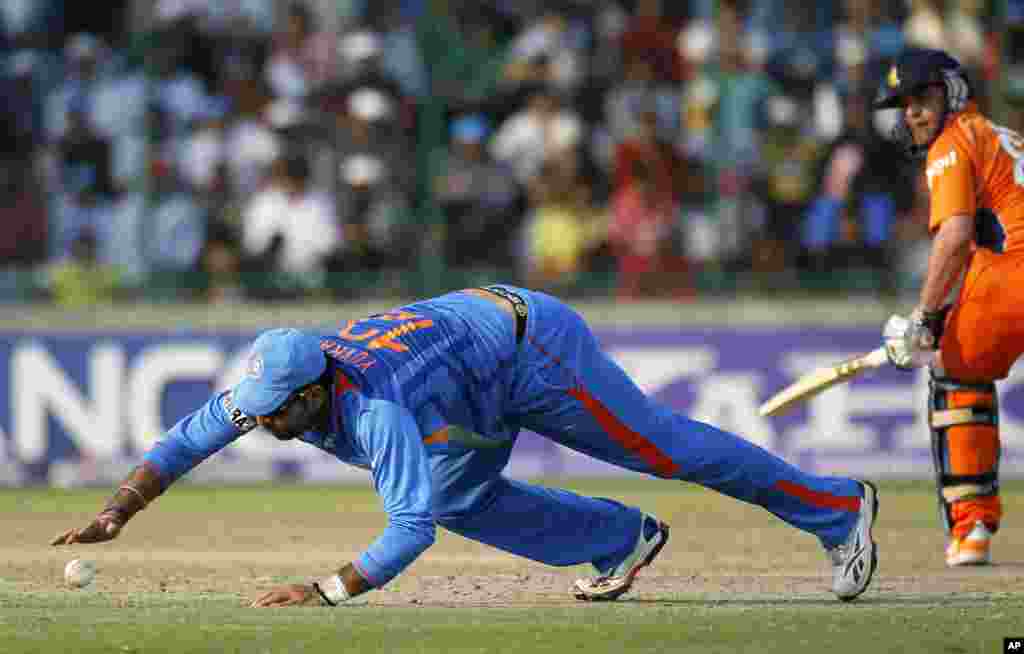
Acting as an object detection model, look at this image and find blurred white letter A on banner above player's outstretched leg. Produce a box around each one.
[690,373,775,449]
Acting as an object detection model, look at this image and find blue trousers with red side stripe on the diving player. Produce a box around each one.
[431,287,861,570]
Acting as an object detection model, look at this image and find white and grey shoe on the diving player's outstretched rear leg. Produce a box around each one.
[827,480,879,602]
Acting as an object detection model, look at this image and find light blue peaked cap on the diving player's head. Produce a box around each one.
[233,329,327,416]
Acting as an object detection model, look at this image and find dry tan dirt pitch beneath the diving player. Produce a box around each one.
[0,481,1024,607]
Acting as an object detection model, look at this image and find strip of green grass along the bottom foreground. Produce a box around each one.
[0,595,1024,654]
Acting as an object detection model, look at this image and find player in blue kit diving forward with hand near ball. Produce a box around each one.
[52,286,879,607]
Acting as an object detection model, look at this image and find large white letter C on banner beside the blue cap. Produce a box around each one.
[128,343,224,451]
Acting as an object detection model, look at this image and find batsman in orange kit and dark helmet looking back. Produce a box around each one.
[874,50,1024,566]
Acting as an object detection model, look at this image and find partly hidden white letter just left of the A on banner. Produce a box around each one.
[608,347,718,394]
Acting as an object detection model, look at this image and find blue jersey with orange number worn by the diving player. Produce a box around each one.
[144,293,517,586]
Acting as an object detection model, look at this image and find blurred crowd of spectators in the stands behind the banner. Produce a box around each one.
[0,0,1002,306]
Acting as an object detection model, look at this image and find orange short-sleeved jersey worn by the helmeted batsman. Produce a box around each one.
[925,102,1024,252]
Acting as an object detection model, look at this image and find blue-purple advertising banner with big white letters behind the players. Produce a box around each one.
[0,328,1024,485]
